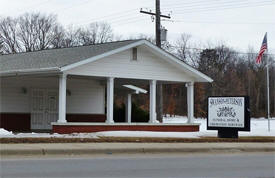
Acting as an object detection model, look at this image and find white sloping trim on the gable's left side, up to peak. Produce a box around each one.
[61,40,145,72]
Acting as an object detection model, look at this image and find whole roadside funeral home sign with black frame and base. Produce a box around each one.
[207,96,250,138]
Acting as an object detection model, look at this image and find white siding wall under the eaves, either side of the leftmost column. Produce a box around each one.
[0,77,105,114]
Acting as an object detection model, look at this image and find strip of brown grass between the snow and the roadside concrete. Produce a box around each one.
[0,136,275,144]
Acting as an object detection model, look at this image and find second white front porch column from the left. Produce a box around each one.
[106,77,114,123]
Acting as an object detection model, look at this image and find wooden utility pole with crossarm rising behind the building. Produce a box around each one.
[140,0,171,122]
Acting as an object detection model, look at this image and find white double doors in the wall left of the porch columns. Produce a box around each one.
[31,89,58,130]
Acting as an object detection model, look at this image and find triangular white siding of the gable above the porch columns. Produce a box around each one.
[67,48,194,82]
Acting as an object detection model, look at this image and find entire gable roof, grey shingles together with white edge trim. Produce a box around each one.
[0,39,213,82]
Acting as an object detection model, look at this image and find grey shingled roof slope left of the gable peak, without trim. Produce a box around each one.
[0,40,140,72]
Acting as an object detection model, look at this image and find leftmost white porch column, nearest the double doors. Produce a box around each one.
[57,74,67,122]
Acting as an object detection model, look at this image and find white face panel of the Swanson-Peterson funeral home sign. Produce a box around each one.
[208,97,245,128]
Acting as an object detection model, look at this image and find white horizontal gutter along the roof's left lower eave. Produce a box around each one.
[0,67,61,77]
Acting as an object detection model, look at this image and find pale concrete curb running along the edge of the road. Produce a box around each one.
[0,147,275,157]
